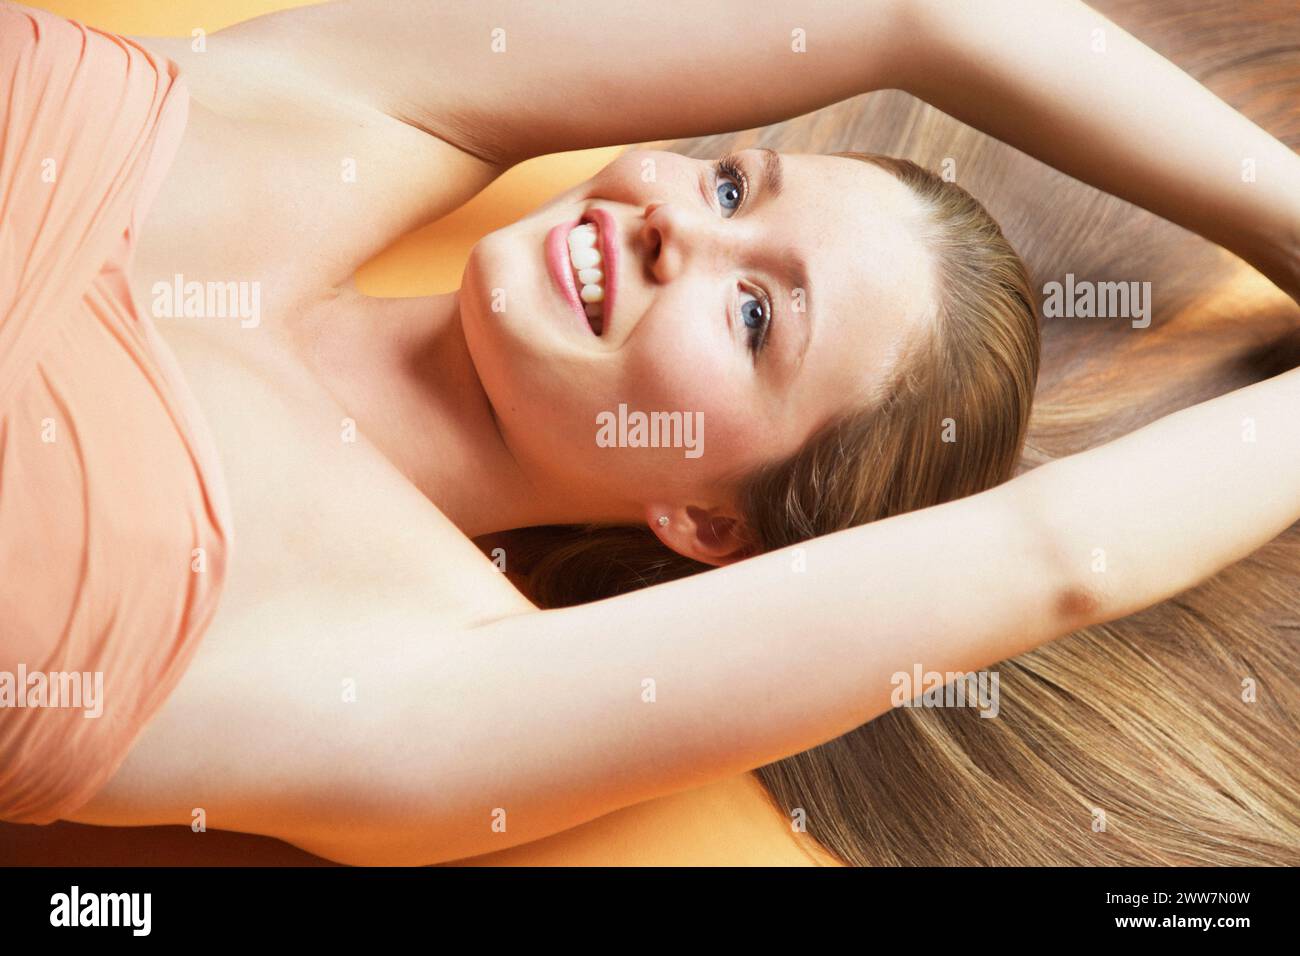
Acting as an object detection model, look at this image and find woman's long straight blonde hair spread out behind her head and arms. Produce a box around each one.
[486,39,1300,865]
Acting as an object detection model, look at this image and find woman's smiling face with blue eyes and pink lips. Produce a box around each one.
[460,150,935,550]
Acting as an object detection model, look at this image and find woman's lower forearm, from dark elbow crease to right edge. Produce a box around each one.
[1017,368,1300,624]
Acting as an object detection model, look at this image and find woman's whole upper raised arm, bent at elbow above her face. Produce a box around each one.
[233,0,1300,299]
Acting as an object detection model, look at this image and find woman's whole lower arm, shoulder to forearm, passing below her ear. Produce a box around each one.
[299,369,1300,864]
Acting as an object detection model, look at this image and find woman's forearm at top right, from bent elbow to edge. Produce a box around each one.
[893,0,1300,300]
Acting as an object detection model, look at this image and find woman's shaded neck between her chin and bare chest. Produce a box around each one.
[311,286,582,537]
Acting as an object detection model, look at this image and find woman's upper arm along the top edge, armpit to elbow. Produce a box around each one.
[208,0,910,166]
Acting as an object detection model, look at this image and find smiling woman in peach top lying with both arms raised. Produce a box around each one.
[0,0,1300,864]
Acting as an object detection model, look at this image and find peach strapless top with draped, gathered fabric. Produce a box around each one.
[0,3,230,823]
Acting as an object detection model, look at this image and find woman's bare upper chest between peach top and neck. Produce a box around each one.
[118,52,523,645]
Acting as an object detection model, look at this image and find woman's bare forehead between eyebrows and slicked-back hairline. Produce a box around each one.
[771,153,935,419]
